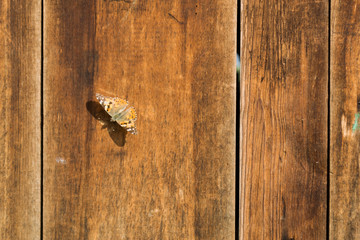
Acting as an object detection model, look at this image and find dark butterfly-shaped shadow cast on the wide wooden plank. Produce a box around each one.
[86,101,128,147]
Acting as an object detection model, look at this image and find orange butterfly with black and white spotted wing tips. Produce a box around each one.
[96,93,137,134]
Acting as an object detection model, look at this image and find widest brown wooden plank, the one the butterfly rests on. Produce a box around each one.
[44,0,236,239]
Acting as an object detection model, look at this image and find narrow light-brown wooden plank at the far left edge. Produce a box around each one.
[0,0,41,239]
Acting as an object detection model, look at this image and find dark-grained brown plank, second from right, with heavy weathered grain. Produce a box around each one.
[240,0,329,239]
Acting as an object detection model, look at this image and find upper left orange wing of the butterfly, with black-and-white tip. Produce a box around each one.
[96,94,129,121]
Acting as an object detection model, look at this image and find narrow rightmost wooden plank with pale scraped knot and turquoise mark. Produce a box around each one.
[330,1,360,240]
